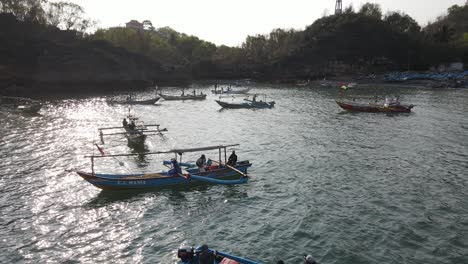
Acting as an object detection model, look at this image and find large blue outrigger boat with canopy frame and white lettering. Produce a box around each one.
[74,144,252,190]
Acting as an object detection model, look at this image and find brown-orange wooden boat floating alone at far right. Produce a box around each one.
[336,97,414,113]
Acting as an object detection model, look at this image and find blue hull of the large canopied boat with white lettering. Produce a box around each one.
[76,161,252,190]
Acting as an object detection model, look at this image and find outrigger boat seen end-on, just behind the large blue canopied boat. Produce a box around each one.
[98,115,167,145]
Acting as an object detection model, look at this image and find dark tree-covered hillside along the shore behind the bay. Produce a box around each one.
[0,0,468,94]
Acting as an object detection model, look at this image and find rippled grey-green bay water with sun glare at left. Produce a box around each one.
[0,85,468,263]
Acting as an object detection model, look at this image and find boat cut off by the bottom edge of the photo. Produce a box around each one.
[177,245,260,264]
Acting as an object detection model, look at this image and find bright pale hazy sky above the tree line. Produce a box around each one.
[67,0,465,46]
